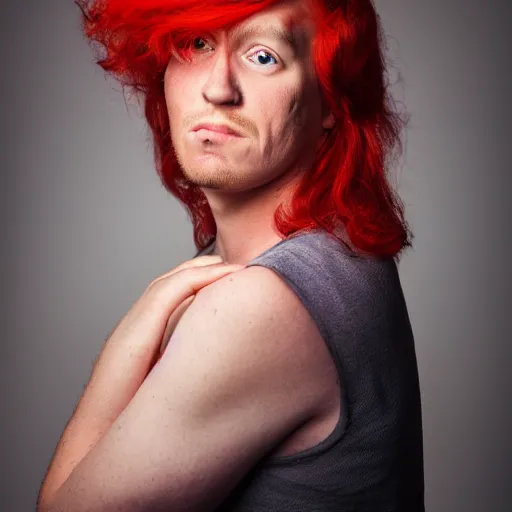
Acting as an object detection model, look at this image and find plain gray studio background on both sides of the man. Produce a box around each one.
[0,0,512,512]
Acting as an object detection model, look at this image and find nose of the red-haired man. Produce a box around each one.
[203,45,242,105]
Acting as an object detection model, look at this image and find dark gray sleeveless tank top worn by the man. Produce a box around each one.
[194,230,425,512]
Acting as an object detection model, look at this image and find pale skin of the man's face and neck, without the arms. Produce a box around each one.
[165,1,334,264]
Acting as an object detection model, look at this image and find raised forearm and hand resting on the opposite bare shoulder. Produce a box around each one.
[38,256,239,508]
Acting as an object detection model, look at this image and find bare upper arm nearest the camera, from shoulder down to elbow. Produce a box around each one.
[51,267,328,512]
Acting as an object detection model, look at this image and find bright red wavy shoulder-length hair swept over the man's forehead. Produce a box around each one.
[76,0,412,257]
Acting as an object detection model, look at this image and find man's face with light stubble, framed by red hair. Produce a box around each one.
[164,1,332,191]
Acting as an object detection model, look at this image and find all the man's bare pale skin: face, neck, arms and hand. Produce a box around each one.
[38,2,338,512]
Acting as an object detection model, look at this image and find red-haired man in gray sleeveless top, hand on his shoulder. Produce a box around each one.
[39,0,424,512]
